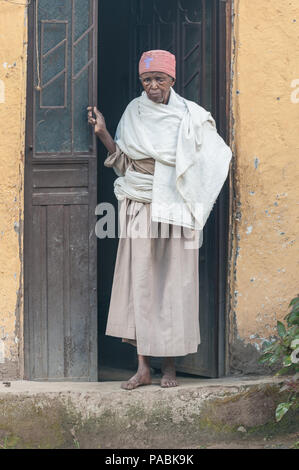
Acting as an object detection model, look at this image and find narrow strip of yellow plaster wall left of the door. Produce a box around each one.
[0,0,27,379]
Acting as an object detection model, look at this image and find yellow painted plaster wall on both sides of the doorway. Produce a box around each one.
[0,0,299,378]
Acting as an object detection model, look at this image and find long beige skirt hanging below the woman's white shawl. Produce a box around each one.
[106,198,200,357]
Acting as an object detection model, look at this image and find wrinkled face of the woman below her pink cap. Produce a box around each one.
[139,72,175,104]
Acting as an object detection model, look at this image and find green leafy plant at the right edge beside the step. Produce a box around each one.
[259,294,299,422]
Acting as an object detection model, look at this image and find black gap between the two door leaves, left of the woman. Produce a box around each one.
[98,0,136,379]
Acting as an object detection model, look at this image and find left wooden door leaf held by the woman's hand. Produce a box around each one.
[24,0,98,381]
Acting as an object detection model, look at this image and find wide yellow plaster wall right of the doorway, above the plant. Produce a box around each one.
[230,0,299,372]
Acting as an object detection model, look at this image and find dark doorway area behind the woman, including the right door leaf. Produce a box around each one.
[98,0,228,380]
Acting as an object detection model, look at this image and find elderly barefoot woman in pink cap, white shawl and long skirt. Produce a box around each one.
[88,50,232,390]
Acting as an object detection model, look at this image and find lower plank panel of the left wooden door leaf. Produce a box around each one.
[29,201,91,380]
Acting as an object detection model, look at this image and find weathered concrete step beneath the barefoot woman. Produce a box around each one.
[0,372,299,449]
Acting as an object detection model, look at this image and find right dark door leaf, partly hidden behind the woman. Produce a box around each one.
[130,0,228,377]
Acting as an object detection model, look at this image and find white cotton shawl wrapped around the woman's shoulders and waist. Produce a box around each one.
[114,88,232,231]
